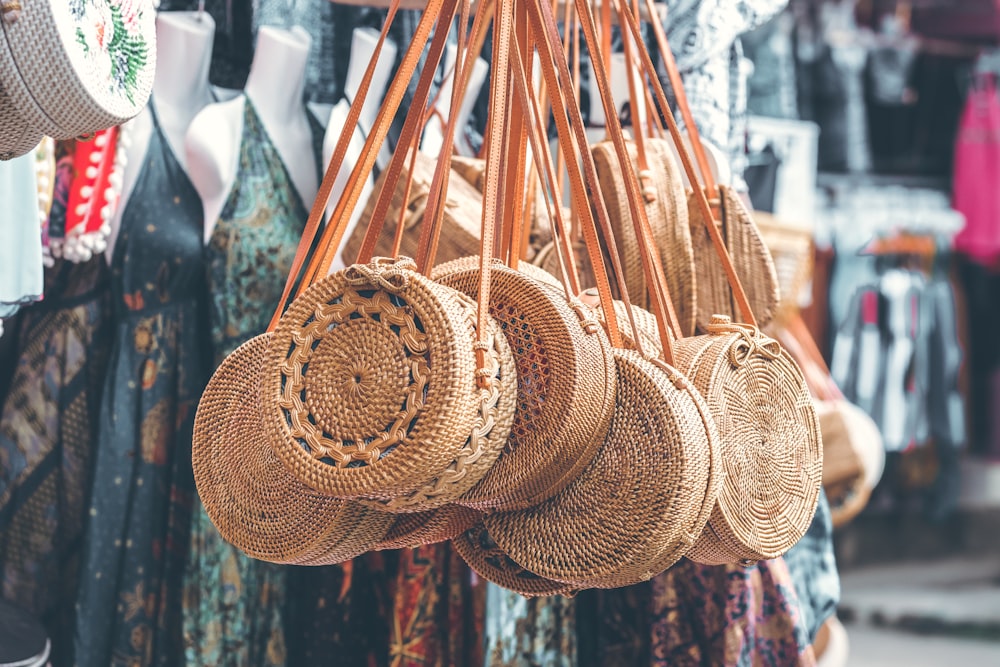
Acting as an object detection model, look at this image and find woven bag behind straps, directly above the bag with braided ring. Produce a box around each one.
[342,153,483,262]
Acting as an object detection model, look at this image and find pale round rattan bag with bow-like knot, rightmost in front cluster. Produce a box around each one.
[675,316,823,565]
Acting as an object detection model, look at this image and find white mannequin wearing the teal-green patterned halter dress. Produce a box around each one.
[185,26,319,242]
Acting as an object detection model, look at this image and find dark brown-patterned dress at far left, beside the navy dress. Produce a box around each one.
[0,254,109,667]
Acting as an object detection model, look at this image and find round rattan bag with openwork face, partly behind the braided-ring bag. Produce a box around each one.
[433,257,615,511]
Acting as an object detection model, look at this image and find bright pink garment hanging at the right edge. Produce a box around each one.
[953,76,1000,265]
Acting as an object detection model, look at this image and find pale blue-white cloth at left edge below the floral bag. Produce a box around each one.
[0,152,43,324]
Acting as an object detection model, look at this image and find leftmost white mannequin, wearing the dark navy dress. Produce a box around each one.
[106,12,215,262]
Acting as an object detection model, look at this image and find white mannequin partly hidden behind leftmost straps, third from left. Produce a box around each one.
[323,28,396,271]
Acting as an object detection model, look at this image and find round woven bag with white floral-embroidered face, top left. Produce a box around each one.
[0,0,156,139]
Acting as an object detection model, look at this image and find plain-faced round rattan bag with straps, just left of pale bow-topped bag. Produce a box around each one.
[483,3,721,588]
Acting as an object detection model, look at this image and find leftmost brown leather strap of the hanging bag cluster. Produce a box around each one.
[267,0,399,331]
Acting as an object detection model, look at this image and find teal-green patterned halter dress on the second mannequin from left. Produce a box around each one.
[184,99,323,667]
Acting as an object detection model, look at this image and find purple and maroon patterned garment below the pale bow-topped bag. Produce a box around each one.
[651,558,816,667]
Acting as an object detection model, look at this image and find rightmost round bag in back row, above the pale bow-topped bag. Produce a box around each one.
[688,186,780,332]
